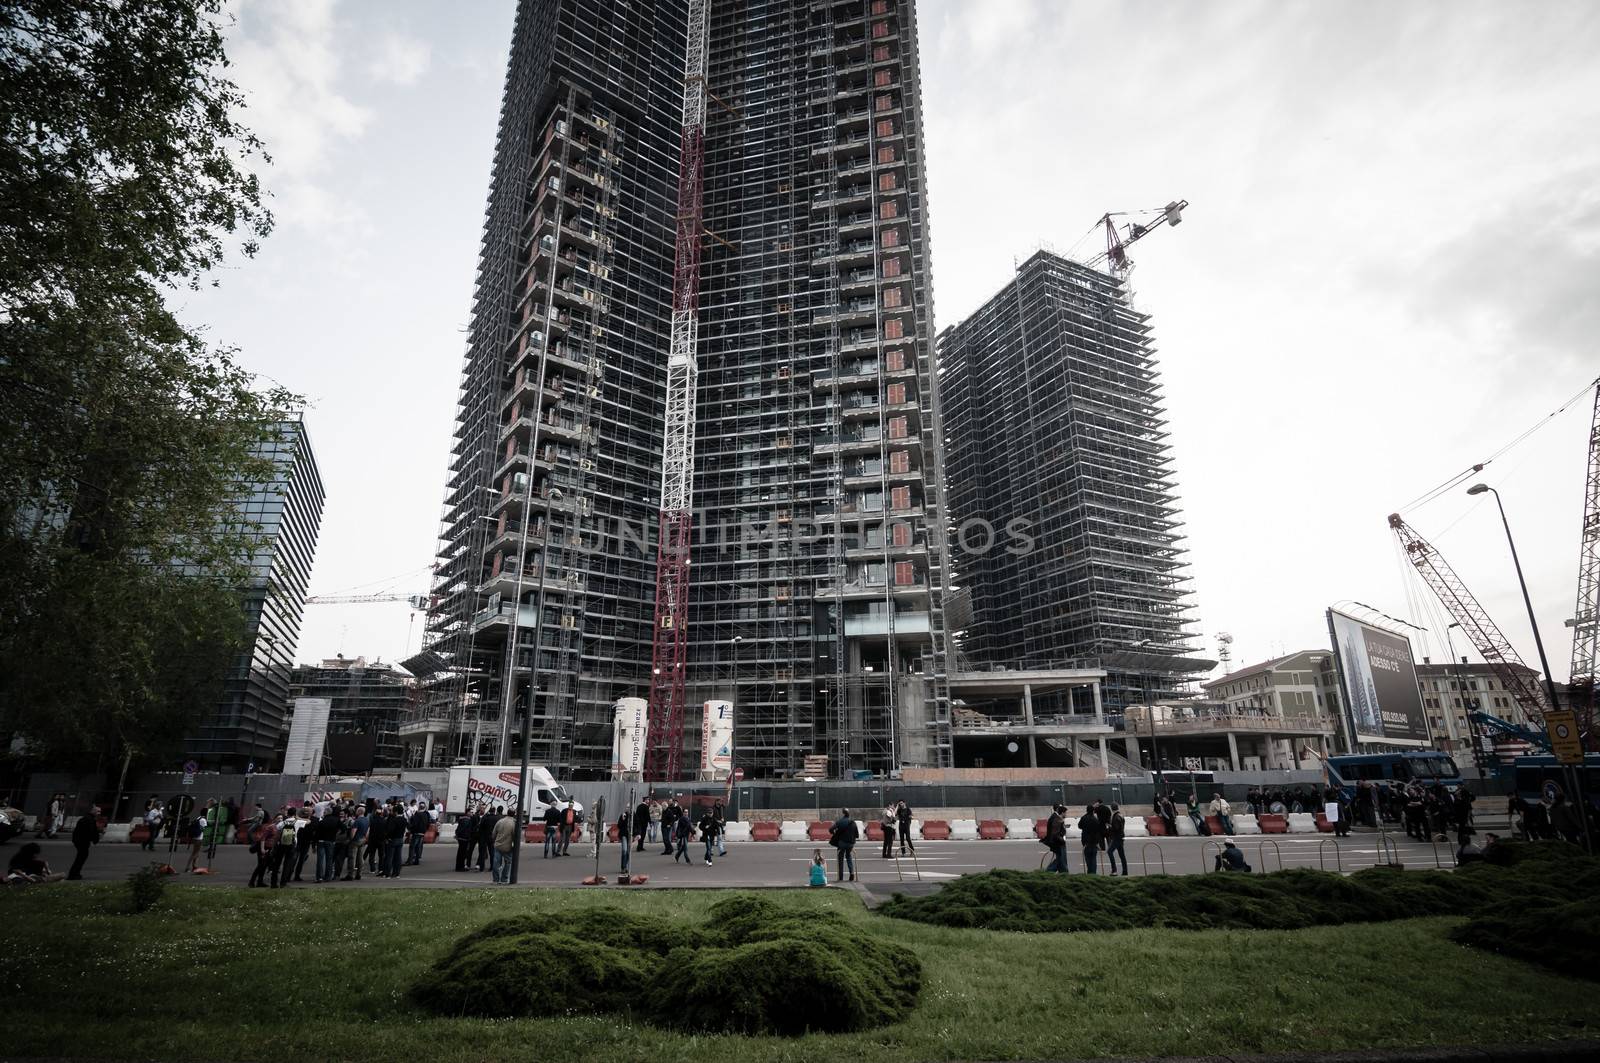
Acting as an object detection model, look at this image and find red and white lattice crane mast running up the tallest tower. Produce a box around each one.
[645,0,710,780]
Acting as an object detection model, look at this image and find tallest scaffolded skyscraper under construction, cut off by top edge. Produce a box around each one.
[419,0,950,776]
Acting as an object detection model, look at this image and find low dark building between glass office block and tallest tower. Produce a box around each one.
[290,655,414,775]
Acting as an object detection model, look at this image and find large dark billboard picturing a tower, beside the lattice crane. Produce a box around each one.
[1328,610,1429,746]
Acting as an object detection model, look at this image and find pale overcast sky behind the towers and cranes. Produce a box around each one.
[174,0,1600,679]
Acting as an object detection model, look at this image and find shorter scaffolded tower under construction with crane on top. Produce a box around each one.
[939,251,1211,709]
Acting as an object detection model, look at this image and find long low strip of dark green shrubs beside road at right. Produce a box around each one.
[880,842,1600,933]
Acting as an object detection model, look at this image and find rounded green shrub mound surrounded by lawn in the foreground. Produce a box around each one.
[411,897,922,1036]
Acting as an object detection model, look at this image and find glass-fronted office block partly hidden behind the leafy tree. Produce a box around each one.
[186,419,325,772]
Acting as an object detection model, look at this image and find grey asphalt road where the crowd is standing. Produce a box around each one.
[12,832,1453,895]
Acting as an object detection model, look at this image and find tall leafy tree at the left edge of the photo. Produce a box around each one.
[0,0,299,778]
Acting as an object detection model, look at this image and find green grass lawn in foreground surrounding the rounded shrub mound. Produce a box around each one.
[0,885,1600,1063]
